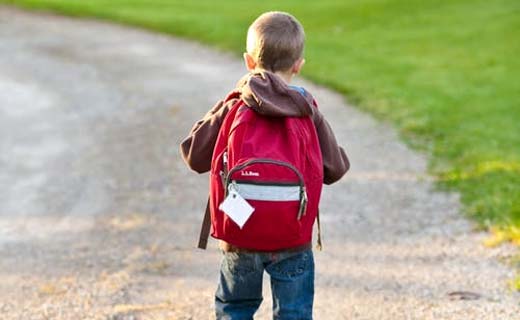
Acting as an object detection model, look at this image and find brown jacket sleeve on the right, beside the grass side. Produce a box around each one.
[314,109,350,184]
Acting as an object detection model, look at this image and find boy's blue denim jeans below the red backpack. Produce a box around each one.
[215,249,314,320]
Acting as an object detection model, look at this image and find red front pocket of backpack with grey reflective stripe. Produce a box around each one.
[220,159,307,248]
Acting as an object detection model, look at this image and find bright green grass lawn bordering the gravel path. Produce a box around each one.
[0,0,520,235]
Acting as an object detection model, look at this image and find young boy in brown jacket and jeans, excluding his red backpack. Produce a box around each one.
[181,12,349,320]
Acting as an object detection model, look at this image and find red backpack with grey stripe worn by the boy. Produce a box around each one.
[199,93,323,251]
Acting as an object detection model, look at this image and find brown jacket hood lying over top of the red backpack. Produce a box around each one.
[237,71,314,117]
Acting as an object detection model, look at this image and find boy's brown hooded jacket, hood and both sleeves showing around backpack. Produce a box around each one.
[180,72,350,184]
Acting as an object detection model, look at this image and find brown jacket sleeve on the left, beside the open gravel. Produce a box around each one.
[180,100,235,173]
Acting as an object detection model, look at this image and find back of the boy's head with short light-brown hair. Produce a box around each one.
[247,11,305,72]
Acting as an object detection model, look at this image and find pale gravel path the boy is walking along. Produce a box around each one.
[0,7,520,320]
